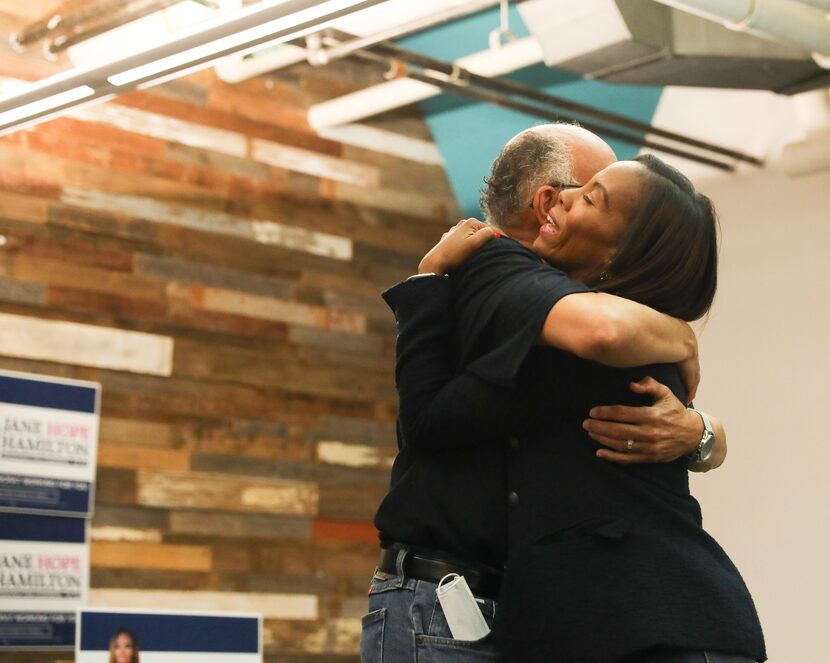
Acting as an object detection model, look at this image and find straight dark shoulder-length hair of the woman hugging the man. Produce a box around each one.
[589,154,718,320]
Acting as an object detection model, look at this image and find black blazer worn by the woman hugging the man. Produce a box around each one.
[385,278,766,663]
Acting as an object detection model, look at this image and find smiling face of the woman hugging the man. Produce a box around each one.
[533,161,644,279]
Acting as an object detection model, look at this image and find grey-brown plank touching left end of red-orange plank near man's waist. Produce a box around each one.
[170,511,311,541]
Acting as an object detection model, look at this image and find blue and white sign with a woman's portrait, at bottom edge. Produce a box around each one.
[75,609,262,663]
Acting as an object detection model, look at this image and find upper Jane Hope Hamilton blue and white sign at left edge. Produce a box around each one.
[0,371,101,517]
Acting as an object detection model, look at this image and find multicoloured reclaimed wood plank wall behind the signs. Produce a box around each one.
[0,54,458,663]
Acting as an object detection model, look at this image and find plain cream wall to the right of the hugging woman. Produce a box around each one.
[692,165,830,663]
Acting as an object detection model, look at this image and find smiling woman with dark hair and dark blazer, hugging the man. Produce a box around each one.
[387,156,766,663]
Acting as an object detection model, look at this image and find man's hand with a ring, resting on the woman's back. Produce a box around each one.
[583,377,703,464]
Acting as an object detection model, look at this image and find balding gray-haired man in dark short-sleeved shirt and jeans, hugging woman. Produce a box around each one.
[361,125,725,663]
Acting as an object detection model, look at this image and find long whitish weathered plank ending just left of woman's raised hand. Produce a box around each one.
[62,186,352,260]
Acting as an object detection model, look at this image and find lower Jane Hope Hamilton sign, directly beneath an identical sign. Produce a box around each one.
[0,513,89,649]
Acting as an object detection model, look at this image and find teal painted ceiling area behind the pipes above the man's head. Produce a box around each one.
[399,6,663,217]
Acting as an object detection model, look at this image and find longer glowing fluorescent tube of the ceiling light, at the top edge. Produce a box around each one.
[107,0,380,86]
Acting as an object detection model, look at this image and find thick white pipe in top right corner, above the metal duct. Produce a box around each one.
[656,0,830,66]
